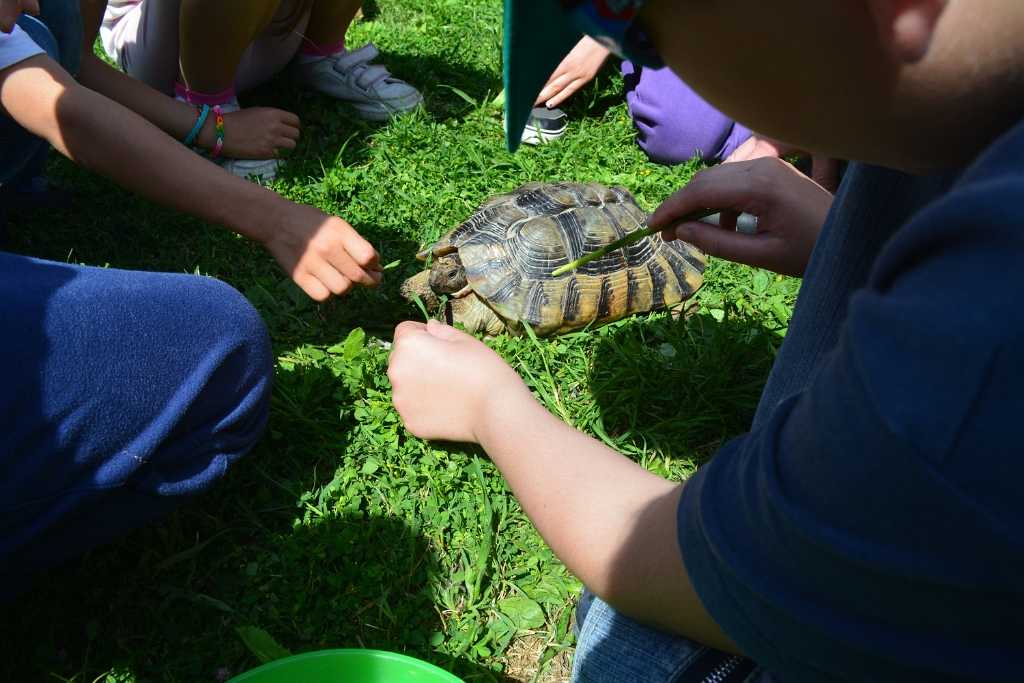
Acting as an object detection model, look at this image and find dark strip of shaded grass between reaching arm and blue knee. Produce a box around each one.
[6,153,423,346]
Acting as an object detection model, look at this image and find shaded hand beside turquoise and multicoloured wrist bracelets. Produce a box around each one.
[211,106,299,159]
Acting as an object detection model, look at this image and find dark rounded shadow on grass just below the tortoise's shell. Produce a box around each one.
[591,314,780,460]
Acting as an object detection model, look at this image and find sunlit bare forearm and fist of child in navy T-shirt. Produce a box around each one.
[388,321,736,651]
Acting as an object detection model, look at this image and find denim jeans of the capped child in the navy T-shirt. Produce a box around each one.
[573,164,955,683]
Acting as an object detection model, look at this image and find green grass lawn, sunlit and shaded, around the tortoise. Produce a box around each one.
[0,0,798,683]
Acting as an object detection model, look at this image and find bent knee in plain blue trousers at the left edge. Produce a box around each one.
[0,252,273,602]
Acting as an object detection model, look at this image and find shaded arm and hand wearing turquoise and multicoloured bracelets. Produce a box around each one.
[78,0,299,159]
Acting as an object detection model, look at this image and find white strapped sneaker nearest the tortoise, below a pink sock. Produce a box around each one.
[291,43,423,121]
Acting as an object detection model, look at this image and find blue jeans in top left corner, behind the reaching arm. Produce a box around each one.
[0,0,82,185]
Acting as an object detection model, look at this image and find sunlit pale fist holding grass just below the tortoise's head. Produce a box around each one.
[387,321,532,442]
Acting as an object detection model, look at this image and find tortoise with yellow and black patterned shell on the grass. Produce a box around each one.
[401,182,706,336]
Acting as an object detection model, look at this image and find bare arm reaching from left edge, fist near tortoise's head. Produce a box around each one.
[0,55,380,300]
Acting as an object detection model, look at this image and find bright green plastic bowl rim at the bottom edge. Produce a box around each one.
[228,649,463,683]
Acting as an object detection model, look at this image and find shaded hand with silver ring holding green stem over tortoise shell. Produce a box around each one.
[649,158,833,275]
